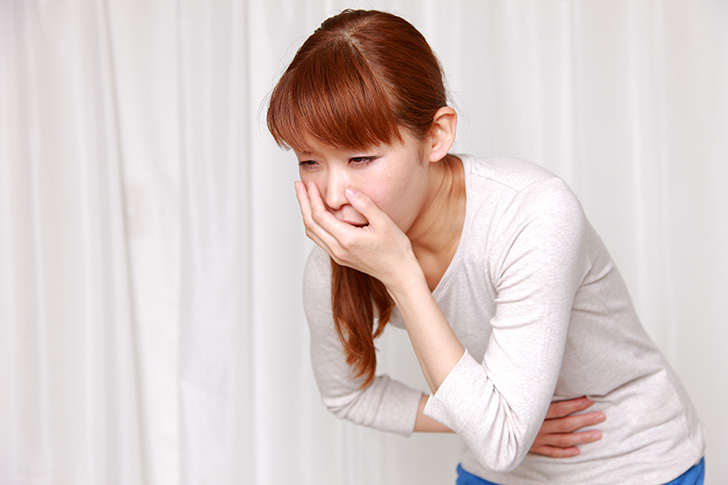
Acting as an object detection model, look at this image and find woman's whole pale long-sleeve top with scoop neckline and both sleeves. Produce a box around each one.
[304,156,705,484]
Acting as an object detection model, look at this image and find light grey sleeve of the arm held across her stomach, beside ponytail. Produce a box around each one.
[303,247,422,436]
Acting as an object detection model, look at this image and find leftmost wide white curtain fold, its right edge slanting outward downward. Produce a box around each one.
[0,2,142,484]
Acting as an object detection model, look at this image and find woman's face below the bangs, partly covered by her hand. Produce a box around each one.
[296,130,430,233]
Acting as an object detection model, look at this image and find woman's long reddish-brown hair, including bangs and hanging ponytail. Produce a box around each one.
[267,10,447,387]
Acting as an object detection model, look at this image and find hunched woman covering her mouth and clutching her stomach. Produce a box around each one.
[268,11,704,484]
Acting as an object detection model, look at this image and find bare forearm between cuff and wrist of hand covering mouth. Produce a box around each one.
[388,270,465,393]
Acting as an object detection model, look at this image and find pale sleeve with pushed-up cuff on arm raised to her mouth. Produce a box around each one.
[425,179,588,472]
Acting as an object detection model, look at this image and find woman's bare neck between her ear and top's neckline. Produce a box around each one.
[407,155,465,274]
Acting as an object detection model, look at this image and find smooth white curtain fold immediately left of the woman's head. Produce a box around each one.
[177,1,255,485]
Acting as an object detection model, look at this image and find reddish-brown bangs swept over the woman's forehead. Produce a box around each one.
[268,39,402,151]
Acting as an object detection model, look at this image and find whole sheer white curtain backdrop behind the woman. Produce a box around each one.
[0,0,728,485]
